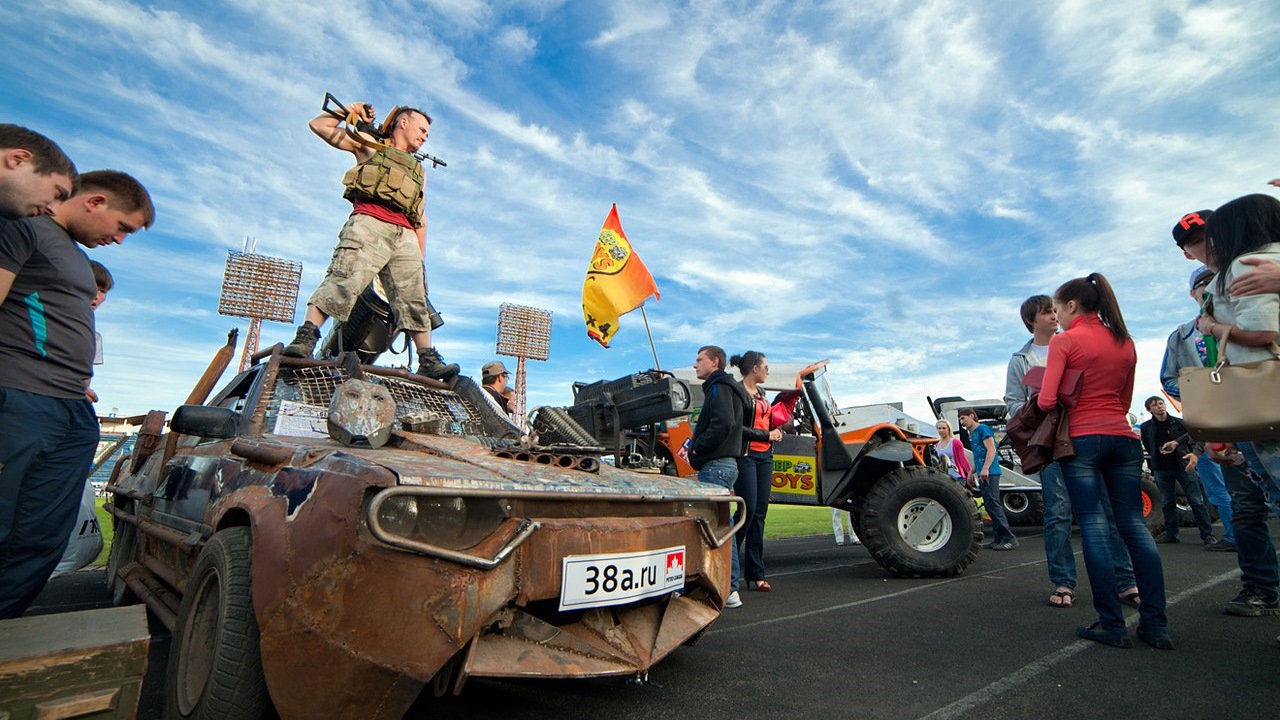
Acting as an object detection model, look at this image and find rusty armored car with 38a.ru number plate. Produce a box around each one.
[108,341,739,720]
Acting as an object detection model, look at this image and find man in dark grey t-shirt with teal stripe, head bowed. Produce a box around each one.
[0,170,155,619]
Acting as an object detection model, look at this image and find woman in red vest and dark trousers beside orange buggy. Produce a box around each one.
[728,350,782,592]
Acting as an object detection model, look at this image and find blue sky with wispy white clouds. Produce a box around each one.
[0,0,1280,418]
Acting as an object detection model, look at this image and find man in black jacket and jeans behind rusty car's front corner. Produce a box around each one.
[689,345,751,607]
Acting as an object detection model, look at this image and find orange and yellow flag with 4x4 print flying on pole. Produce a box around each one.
[582,205,662,347]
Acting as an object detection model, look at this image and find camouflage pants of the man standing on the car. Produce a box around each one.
[307,210,431,332]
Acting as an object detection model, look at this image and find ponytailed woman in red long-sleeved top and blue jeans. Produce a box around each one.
[1037,273,1174,650]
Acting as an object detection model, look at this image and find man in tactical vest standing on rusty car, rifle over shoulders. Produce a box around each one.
[284,102,458,380]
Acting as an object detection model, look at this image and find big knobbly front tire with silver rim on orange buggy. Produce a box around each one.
[859,465,982,578]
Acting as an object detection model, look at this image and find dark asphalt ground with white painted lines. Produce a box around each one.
[32,521,1280,720]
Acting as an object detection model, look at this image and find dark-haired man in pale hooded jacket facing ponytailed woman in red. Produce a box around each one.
[1005,295,1138,607]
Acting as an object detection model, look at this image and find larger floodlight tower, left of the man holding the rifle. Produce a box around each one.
[218,237,302,372]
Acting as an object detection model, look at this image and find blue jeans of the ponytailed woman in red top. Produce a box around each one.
[1061,436,1169,633]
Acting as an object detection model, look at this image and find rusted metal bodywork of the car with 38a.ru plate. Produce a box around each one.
[110,348,737,720]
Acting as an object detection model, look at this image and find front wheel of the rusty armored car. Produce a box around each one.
[165,520,271,720]
